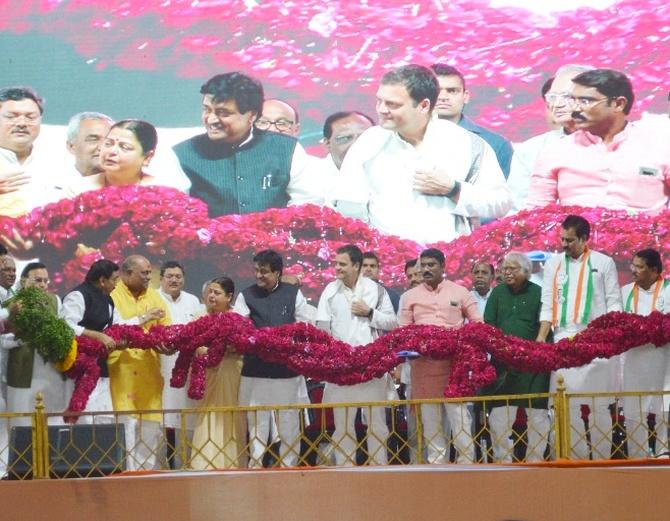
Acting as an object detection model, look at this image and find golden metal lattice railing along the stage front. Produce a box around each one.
[0,383,670,480]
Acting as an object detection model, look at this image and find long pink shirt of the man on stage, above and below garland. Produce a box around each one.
[398,280,482,400]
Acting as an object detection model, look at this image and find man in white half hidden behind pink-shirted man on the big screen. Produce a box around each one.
[507,64,591,212]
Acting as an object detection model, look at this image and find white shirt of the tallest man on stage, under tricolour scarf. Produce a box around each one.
[540,251,623,340]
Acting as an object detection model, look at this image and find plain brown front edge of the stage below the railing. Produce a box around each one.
[0,460,670,521]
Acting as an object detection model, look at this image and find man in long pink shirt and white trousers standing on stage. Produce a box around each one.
[398,248,482,463]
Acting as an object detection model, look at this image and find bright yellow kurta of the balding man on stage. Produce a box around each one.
[107,281,171,421]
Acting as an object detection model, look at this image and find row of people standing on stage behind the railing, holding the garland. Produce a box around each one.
[0,215,670,468]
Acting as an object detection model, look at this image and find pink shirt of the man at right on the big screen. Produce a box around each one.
[526,121,670,214]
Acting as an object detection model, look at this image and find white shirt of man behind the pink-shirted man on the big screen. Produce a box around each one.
[507,128,566,214]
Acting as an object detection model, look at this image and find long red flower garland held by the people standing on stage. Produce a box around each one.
[67,312,670,411]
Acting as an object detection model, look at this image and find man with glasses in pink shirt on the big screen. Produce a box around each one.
[528,69,670,214]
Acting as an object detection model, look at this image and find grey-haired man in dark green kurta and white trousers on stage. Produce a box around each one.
[482,252,549,463]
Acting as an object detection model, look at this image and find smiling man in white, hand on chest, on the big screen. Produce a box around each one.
[334,65,511,243]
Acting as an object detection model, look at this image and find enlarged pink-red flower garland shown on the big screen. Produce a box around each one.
[0,186,670,298]
